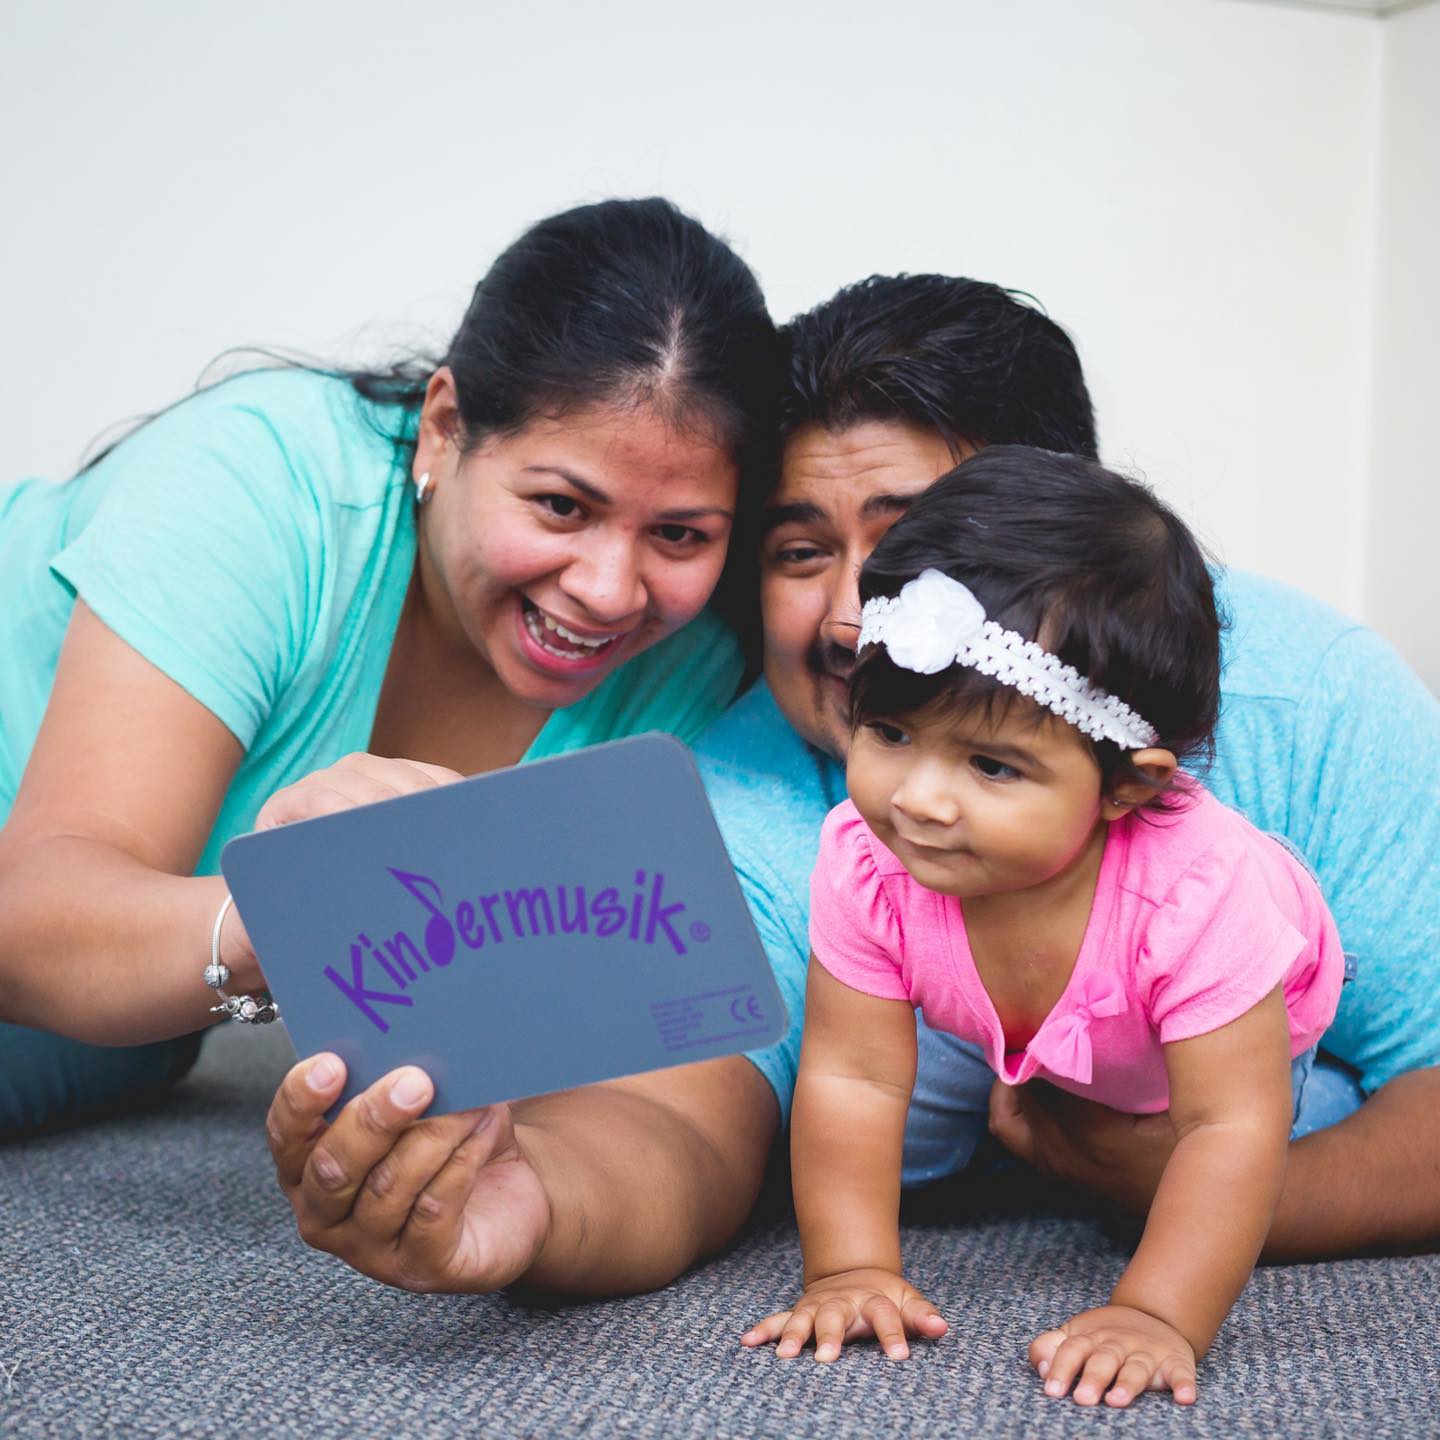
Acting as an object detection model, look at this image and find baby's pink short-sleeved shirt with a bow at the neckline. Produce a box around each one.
[811,786,1345,1115]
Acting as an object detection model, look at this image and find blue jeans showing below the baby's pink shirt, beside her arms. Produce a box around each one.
[901,1025,1365,1185]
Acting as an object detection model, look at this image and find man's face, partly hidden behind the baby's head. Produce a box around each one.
[760,420,973,759]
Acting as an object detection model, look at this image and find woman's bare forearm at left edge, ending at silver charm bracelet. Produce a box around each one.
[0,832,261,1045]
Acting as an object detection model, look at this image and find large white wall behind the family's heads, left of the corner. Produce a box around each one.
[0,0,1411,659]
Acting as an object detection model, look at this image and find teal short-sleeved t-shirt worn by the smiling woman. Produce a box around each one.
[0,370,742,874]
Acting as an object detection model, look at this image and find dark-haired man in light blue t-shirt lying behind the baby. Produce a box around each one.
[269,276,1440,1295]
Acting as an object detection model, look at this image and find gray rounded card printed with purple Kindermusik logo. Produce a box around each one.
[222,734,786,1112]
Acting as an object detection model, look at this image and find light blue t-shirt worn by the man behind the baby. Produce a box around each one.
[697,570,1440,1115]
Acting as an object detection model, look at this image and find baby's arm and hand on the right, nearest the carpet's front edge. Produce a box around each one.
[1031,989,1293,1405]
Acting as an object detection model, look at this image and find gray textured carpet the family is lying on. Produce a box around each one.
[0,1027,1440,1440]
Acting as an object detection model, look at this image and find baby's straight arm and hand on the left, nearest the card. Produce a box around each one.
[742,956,948,1361]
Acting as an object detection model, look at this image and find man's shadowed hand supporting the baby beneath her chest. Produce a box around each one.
[989,1080,1175,1215]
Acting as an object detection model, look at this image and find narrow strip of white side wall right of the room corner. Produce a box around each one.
[1367,4,1440,691]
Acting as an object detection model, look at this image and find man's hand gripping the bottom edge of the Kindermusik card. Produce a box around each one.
[266,1054,550,1292]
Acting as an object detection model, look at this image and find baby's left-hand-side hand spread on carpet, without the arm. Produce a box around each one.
[740,1270,949,1361]
